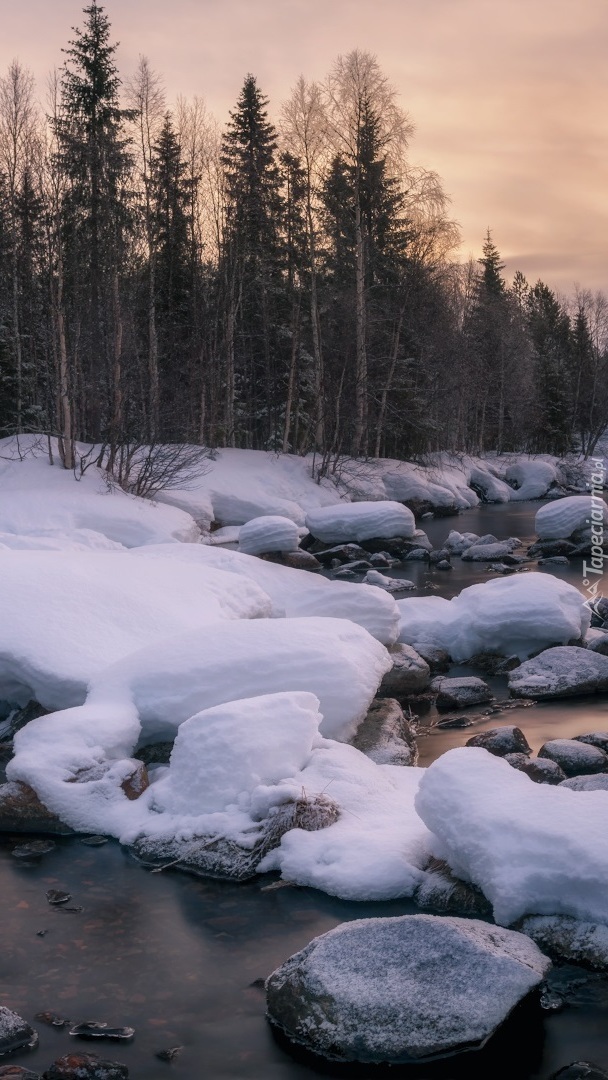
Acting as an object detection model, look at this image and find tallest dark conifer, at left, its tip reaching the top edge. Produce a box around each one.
[52,3,132,441]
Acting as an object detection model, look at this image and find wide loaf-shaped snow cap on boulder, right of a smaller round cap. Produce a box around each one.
[306,501,416,543]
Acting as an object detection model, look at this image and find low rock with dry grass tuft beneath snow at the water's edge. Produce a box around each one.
[130,795,339,881]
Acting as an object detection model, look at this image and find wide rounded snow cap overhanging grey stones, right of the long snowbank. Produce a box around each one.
[396,572,591,660]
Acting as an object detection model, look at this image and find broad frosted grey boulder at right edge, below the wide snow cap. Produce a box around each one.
[509,645,608,701]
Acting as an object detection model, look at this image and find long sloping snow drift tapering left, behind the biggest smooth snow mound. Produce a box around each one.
[131,544,400,645]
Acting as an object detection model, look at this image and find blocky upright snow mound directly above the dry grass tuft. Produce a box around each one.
[154,692,321,814]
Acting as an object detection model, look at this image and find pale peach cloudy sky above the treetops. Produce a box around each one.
[0,0,608,295]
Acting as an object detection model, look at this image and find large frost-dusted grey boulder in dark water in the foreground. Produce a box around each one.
[266,915,550,1064]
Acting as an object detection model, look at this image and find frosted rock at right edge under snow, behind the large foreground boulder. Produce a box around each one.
[518,915,608,972]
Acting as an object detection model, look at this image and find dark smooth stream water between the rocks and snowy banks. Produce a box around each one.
[0,503,608,1080]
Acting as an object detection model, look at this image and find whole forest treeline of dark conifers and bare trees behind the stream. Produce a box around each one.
[0,3,608,467]
